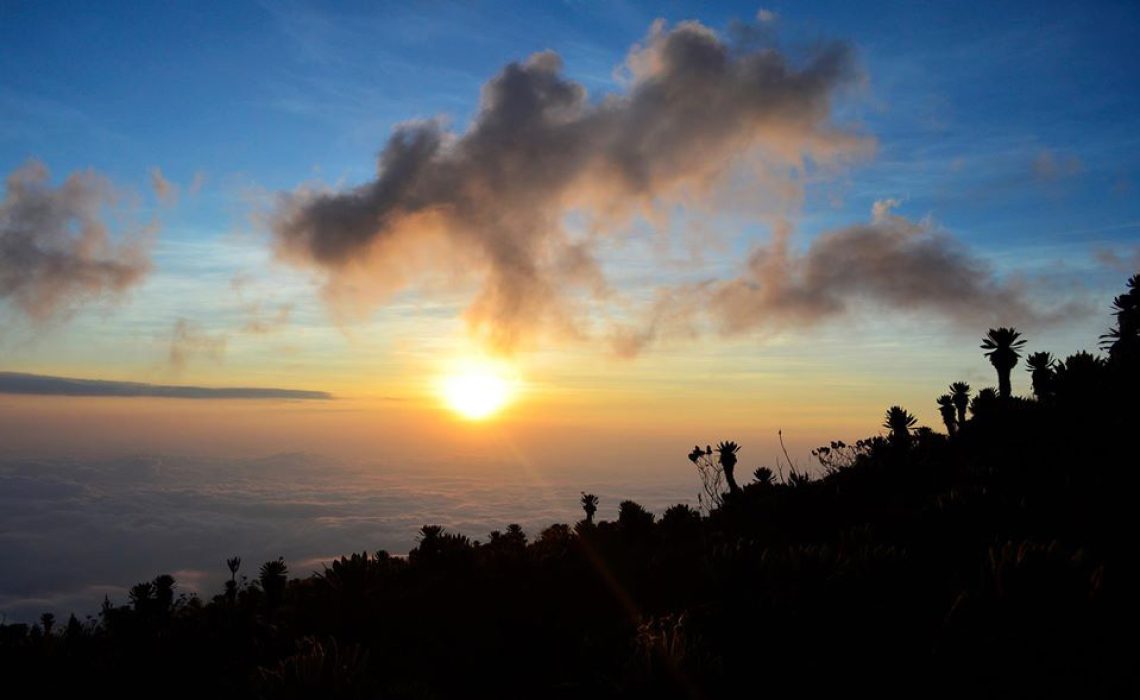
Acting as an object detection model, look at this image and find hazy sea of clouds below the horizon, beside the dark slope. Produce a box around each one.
[0,454,699,621]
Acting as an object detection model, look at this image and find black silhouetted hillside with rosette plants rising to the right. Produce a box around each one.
[0,276,1140,700]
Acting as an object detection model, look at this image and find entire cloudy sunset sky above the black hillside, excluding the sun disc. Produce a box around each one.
[0,0,1140,624]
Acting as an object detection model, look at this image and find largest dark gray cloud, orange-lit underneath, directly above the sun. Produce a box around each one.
[271,22,871,349]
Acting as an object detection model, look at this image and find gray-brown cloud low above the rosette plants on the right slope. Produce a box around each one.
[611,200,1088,357]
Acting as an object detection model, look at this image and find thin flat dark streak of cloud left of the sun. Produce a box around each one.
[0,372,332,399]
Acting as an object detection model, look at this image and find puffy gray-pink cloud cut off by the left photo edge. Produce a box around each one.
[0,162,153,321]
